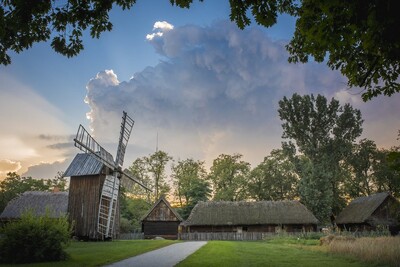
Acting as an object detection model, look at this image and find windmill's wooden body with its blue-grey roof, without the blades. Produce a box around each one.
[64,153,120,240]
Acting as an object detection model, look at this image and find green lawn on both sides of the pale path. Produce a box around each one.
[0,238,399,267]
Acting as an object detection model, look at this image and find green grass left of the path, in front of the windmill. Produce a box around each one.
[0,240,176,267]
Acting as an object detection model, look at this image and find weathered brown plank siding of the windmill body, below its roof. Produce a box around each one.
[68,174,120,239]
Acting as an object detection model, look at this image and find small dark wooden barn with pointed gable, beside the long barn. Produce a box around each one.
[142,196,183,239]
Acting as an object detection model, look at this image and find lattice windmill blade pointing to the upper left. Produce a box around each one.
[74,125,116,169]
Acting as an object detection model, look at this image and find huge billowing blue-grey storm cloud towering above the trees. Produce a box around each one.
[86,22,398,169]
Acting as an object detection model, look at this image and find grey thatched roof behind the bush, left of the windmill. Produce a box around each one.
[0,191,68,220]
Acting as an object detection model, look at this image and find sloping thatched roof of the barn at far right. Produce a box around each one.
[336,192,393,224]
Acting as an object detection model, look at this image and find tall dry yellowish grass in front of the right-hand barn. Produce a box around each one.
[328,236,400,266]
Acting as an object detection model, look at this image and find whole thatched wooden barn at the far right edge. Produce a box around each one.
[336,192,400,234]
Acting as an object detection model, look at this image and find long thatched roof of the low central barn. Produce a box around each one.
[184,201,318,226]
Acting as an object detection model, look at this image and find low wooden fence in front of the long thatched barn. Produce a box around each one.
[178,232,276,241]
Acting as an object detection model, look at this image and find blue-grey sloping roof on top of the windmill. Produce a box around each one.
[64,153,104,177]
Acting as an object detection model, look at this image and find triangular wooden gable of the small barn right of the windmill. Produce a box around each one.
[142,197,183,222]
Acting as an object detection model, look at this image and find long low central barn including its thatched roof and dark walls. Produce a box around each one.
[182,201,318,237]
